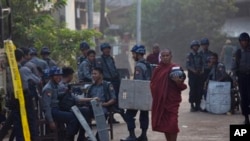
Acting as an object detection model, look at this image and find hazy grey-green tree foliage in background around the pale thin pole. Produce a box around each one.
[125,0,237,65]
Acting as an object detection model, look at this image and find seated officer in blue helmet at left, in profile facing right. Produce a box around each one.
[42,66,79,141]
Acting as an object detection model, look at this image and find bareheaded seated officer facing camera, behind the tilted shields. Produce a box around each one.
[87,68,116,114]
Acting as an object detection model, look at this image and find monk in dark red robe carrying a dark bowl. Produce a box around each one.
[150,49,187,141]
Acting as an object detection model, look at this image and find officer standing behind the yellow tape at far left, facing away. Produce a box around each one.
[12,49,41,141]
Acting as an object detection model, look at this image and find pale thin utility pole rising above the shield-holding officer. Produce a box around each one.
[136,0,141,45]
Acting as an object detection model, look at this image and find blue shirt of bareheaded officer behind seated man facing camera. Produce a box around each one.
[78,59,95,82]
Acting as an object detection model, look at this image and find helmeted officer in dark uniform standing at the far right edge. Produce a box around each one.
[232,32,250,124]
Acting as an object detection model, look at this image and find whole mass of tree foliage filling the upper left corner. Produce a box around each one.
[1,0,100,68]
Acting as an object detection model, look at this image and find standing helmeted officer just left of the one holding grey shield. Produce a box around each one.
[96,43,124,123]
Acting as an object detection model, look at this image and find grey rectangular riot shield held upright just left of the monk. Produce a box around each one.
[119,79,152,111]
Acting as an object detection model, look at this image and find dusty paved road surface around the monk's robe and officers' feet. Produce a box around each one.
[110,83,244,141]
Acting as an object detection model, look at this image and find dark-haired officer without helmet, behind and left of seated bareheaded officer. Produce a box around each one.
[78,49,96,83]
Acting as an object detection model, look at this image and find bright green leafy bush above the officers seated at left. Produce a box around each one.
[28,16,101,68]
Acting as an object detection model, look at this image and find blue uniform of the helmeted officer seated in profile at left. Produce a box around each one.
[42,80,79,137]
